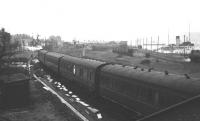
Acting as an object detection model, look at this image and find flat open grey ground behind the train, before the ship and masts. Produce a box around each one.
[60,50,200,77]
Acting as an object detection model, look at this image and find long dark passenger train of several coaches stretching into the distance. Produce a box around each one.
[38,50,200,115]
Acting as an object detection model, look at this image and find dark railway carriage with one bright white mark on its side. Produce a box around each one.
[60,55,104,91]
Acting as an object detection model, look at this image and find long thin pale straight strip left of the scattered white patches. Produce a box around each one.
[33,74,89,121]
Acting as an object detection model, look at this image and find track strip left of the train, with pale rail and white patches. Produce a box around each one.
[33,74,101,121]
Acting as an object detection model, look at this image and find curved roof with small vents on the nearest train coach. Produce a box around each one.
[101,64,200,96]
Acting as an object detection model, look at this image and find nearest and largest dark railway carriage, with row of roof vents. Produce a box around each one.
[99,64,200,114]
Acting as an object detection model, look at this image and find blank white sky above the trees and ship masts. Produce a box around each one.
[0,0,200,43]
